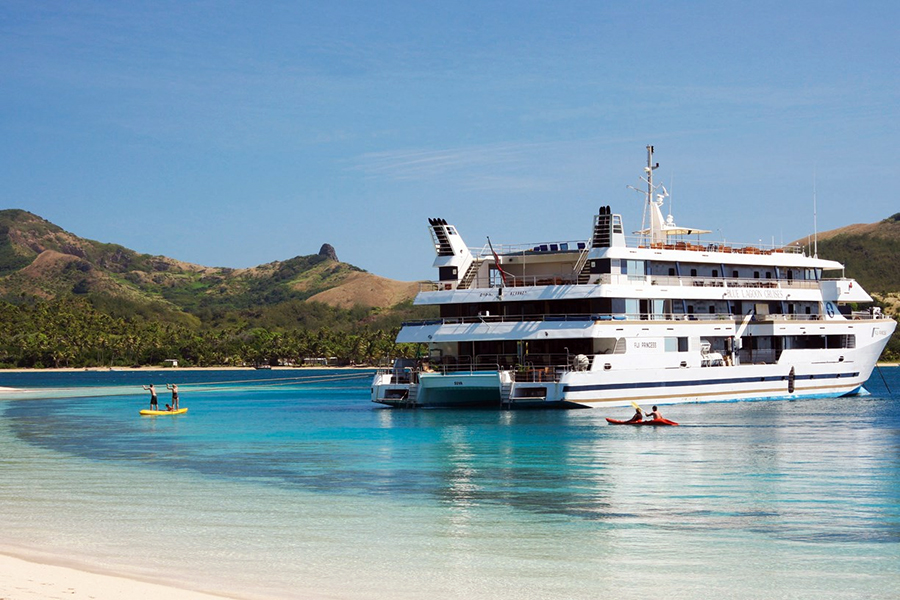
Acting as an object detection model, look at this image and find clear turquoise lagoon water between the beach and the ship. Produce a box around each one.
[0,368,900,599]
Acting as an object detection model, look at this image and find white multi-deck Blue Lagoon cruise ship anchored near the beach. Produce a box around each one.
[372,146,896,408]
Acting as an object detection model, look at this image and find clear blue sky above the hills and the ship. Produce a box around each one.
[0,0,900,280]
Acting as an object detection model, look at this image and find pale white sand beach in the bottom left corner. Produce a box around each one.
[0,554,244,600]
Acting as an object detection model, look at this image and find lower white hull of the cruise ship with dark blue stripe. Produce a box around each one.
[373,319,895,408]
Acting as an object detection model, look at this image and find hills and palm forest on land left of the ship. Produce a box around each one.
[0,209,434,367]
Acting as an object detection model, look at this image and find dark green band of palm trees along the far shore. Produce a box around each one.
[0,299,423,369]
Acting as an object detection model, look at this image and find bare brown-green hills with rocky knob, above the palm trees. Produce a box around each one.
[0,209,416,324]
